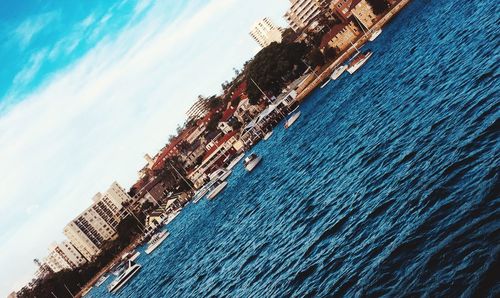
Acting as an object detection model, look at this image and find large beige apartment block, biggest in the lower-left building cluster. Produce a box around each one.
[64,182,131,260]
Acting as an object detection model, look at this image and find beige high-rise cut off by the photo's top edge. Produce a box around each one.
[284,0,321,31]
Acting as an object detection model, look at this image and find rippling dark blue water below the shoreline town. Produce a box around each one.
[90,0,500,297]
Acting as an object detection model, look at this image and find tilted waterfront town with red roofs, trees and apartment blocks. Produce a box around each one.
[13,0,409,297]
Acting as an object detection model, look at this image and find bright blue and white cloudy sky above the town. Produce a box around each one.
[0,0,289,297]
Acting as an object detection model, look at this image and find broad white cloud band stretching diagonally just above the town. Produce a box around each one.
[0,0,288,295]
